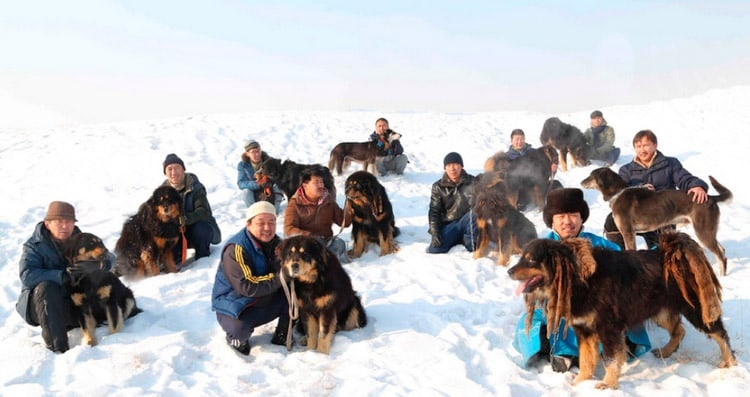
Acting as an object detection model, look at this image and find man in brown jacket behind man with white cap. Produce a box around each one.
[284,166,353,263]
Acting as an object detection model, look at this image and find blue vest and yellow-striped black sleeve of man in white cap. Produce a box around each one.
[211,228,281,318]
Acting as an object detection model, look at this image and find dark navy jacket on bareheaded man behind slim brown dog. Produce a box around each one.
[618,151,708,191]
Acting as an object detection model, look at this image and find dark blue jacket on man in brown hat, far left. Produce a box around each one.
[16,222,81,326]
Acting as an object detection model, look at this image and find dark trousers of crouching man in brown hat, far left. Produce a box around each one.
[29,281,78,353]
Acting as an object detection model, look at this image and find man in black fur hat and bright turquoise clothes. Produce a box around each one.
[513,188,651,372]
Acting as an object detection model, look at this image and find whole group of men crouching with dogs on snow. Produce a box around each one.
[16,111,708,371]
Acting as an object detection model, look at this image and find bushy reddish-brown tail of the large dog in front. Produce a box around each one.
[659,232,721,326]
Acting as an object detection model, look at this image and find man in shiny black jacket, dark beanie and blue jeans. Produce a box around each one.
[427,152,479,254]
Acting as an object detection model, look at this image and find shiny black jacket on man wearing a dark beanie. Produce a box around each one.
[428,170,474,234]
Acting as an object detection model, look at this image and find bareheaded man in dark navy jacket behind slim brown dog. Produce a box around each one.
[604,130,708,248]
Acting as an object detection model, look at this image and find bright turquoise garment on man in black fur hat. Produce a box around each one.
[513,231,651,365]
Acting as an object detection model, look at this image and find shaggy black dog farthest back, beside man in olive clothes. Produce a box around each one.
[539,117,591,171]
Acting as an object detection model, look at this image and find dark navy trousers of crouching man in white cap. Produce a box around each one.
[216,289,289,341]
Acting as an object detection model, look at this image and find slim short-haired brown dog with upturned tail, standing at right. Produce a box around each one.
[581,167,732,276]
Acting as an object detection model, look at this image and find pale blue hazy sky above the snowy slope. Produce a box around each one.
[0,0,750,123]
